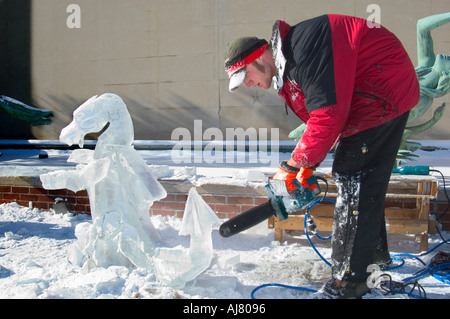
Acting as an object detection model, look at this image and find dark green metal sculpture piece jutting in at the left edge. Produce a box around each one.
[0,95,53,126]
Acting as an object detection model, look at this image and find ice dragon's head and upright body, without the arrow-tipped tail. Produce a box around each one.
[40,94,166,268]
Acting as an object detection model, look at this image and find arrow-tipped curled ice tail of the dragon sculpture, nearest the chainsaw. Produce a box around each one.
[153,188,219,289]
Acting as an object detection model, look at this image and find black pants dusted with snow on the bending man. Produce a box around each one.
[331,112,409,282]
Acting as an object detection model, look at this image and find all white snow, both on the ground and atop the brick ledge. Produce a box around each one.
[0,141,450,299]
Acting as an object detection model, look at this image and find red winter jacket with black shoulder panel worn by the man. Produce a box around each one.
[272,15,420,167]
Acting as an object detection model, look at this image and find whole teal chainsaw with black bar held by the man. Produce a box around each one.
[219,176,321,237]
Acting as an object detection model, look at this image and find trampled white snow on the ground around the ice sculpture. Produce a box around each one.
[0,204,450,299]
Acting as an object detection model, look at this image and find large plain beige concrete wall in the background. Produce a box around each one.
[16,0,450,139]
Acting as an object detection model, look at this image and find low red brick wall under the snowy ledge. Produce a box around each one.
[0,177,450,230]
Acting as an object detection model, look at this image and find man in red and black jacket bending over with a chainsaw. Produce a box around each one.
[225,14,420,298]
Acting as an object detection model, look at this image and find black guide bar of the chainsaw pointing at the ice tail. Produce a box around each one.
[219,202,275,237]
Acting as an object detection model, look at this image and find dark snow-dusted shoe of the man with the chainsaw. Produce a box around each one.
[315,278,370,299]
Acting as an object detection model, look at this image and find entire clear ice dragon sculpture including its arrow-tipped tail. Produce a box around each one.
[40,93,218,288]
